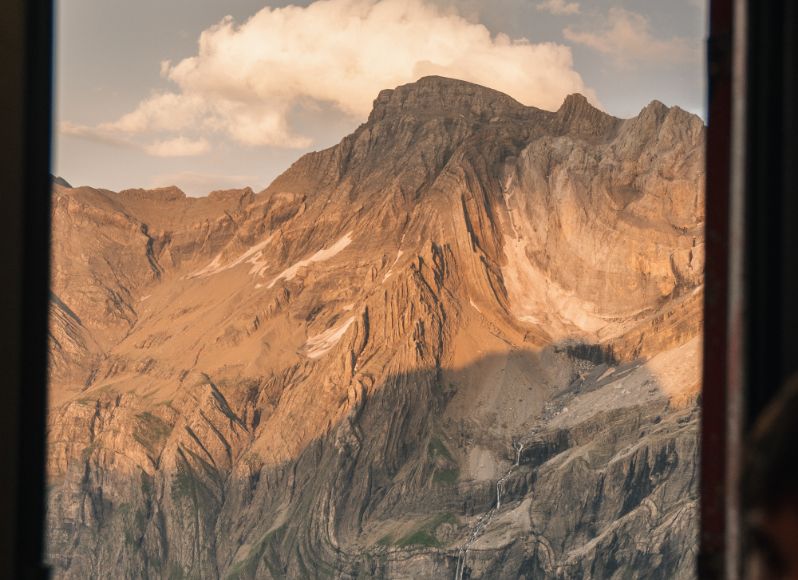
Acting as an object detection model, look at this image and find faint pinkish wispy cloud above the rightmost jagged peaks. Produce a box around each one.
[563,7,700,68]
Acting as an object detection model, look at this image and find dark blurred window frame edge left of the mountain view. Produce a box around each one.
[0,0,53,579]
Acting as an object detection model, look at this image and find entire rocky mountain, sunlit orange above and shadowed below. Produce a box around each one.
[48,77,705,579]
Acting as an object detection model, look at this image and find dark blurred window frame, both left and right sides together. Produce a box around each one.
[0,0,798,579]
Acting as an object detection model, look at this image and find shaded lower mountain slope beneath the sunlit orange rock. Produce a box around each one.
[49,339,698,578]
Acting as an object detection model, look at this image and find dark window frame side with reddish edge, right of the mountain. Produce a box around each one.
[698,0,798,579]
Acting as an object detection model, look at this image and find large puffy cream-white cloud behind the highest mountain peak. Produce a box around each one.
[92,0,595,150]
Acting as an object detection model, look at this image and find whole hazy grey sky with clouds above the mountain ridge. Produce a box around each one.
[53,0,707,196]
